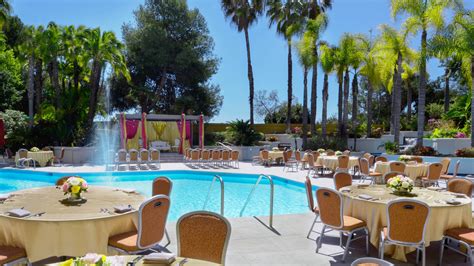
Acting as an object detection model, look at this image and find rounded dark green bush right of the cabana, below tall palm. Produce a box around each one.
[225,119,262,146]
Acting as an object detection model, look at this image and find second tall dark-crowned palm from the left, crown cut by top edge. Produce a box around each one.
[267,0,304,133]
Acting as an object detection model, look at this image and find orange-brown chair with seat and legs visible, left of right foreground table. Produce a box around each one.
[316,188,369,262]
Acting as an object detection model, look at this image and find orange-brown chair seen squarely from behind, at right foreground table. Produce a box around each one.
[379,198,430,266]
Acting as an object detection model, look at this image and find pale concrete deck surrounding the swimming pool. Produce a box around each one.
[2,162,469,265]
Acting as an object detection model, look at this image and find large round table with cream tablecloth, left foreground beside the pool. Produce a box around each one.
[0,186,145,262]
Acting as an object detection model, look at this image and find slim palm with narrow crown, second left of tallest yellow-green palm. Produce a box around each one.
[359,32,381,137]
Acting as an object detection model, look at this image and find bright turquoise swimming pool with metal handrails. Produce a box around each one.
[0,169,314,221]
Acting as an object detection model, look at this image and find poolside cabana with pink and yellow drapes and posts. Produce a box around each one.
[119,113,204,153]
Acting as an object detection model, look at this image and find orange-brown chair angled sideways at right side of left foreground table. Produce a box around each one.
[108,195,170,254]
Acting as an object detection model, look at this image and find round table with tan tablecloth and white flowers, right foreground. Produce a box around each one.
[340,185,472,262]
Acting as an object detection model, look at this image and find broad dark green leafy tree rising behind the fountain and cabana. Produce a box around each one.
[111,0,222,117]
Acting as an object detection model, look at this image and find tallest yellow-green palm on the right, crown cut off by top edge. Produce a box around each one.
[391,0,460,146]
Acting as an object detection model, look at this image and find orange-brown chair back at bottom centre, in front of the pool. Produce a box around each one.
[176,211,232,265]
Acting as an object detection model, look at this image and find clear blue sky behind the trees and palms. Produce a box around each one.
[12,0,474,122]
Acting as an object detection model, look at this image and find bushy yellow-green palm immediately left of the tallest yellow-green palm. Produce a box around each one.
[375,25,413,147]
